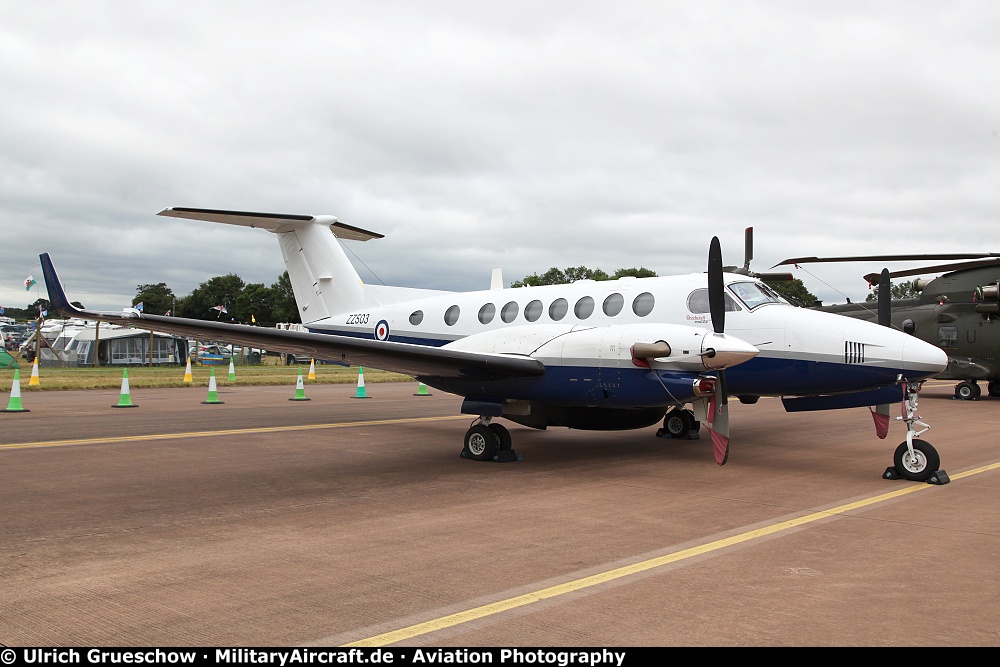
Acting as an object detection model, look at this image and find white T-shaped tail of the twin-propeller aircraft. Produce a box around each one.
[159,207,382,324]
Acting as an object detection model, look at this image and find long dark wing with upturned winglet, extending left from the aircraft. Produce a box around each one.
[39,253,545,379]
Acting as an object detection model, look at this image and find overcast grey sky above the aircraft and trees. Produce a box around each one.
[0,0,1000,309]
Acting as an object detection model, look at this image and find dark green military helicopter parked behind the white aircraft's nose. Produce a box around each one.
[772,253,1000,400]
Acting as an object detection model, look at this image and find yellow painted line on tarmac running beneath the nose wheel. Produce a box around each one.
[344,463,1000,646]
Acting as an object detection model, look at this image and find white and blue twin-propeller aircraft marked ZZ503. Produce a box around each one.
[41,208,948,482]
